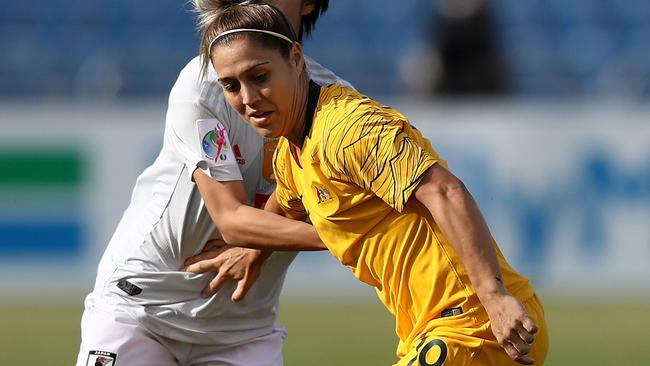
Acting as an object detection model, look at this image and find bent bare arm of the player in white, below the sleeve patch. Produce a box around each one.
[192,169,326,251]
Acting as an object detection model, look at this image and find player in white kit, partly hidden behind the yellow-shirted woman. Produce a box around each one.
[77,0,350,366]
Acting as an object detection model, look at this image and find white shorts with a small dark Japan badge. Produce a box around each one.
[77,307,287,366]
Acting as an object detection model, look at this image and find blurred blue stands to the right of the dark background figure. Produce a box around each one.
[490,0,650,98]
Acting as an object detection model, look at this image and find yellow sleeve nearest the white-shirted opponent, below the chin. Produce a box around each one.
[273,138,306,213]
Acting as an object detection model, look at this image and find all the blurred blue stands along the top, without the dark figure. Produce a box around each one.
[0,0,650,100]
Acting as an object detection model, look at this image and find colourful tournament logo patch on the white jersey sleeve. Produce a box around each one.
[196,119,237,167]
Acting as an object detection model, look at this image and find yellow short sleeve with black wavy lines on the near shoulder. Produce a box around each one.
[327,118,439,212]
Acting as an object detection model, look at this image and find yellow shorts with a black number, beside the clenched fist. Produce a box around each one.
[395,295,549,366]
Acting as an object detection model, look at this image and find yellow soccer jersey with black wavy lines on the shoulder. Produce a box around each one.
[274,83,533,357]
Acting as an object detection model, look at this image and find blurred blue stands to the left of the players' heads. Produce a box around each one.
[0,0,198,98]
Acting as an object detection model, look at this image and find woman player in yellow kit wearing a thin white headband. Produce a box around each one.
[196,5,548,366]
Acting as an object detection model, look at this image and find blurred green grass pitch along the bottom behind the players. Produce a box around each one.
[0,298,650,366]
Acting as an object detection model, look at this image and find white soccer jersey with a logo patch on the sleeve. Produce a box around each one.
[91,53,345,344]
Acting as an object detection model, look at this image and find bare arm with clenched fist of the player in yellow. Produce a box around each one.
[414,164,537,365]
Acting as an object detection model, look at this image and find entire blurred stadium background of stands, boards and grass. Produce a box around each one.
[0,0,650,365]
